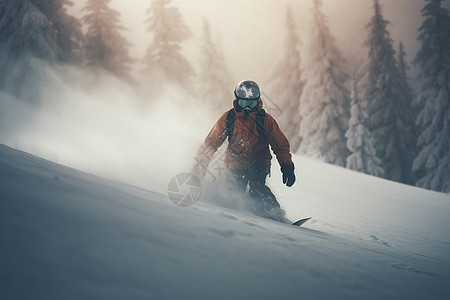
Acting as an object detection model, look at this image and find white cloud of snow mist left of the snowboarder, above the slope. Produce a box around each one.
[0,64,214,193]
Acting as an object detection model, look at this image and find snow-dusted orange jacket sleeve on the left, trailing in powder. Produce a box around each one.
[192,112,228,178]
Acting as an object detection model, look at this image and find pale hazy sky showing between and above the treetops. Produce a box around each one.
[74,0,449,86]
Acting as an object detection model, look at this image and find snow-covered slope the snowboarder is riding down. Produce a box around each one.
[0,145,450,299]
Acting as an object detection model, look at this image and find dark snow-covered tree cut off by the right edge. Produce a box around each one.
[413,0,450,193]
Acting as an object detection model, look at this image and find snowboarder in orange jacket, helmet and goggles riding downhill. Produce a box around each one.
[193,80,295,221]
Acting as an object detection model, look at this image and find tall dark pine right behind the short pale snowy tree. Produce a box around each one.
[364,0,416,183]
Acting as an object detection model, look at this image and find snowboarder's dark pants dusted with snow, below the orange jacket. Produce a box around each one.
[231,163,284,219]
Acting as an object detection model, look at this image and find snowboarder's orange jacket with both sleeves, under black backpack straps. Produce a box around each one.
[196,100,294,169]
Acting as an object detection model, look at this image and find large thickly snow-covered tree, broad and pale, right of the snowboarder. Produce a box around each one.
[299,0,350,166]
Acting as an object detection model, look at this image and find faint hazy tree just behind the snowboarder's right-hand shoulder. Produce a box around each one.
[268,7,303,152]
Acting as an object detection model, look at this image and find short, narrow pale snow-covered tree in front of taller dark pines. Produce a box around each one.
[345,76,384,177]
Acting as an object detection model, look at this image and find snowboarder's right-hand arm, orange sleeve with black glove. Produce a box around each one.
[266,114,295,187]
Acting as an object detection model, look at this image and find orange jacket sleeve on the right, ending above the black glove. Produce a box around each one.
[266,114,294,166]
